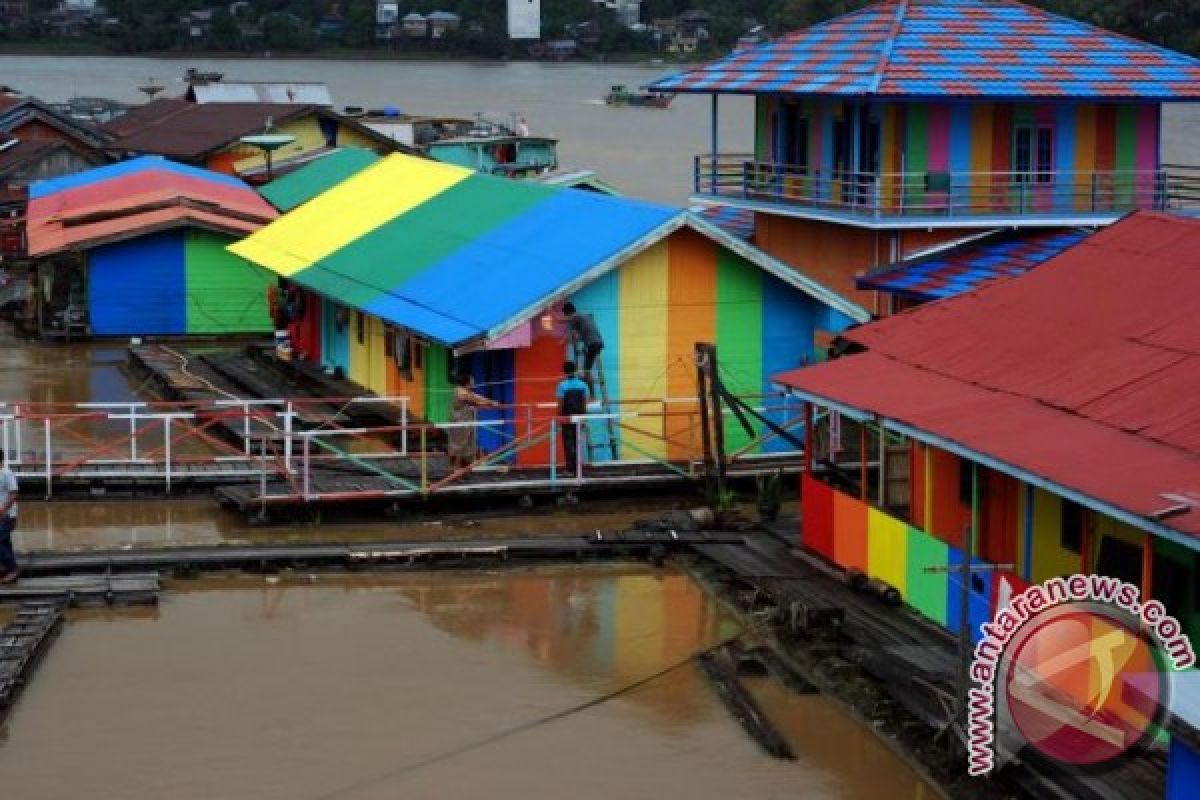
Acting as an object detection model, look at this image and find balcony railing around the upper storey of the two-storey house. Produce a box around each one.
[695,155,1200,221]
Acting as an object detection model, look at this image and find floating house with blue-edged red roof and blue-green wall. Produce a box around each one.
[28,157,277,336]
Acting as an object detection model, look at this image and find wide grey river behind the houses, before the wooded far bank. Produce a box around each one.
[0,55,1200,204]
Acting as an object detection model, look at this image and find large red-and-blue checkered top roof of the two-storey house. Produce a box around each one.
[648,0,1200,102]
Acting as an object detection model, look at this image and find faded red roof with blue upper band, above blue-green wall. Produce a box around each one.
[26,156,277,257]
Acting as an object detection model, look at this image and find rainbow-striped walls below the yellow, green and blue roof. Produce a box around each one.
[298,228,851,464]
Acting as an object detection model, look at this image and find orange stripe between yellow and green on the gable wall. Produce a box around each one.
[665,229,716,458]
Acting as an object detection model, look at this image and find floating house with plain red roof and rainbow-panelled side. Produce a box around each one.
[776,212,1200,640]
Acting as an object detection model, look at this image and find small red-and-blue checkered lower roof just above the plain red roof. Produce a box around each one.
[856,229,1091,301]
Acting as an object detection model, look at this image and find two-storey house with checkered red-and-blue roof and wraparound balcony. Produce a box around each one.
[648,0,1200,312]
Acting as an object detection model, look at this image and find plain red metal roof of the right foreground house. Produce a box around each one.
[775,212,1200,535]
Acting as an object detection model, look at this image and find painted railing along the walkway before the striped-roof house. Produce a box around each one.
[0,395,803,501]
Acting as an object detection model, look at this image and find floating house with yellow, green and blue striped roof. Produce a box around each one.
[230,155,866,463]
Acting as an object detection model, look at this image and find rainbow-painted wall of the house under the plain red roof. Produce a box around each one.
[800,443,1200,638]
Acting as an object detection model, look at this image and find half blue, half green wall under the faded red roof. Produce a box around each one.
[86,229,275,336]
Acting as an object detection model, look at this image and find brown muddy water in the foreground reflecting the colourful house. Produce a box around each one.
[0,569,932,800]
